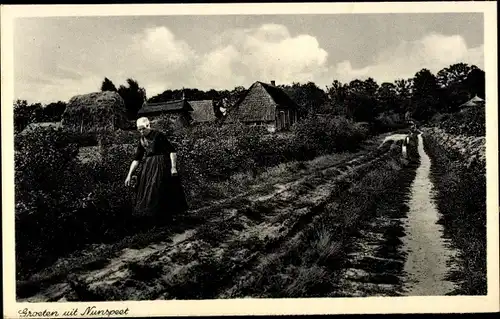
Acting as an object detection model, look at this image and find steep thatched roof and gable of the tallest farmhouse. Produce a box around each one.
[227,81,297,122]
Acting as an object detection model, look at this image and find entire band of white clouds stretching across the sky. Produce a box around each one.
[16,24,484,103]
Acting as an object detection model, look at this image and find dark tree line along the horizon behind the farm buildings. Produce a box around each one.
[14,63,485,134]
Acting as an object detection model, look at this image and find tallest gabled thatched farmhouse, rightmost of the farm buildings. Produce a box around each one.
[225,81,298,132]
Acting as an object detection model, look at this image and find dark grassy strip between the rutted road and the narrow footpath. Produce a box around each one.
[221,143,418,298]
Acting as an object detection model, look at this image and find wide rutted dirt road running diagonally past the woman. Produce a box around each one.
[18,137,400,302]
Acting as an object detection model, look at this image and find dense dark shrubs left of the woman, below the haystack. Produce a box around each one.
[15,130,139,275]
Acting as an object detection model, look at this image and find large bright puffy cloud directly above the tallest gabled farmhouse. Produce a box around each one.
[201,24,328,87]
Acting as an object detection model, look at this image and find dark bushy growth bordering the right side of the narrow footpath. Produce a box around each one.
[424,129,487,295]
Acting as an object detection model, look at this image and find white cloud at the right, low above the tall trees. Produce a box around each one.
[334,33,484,83]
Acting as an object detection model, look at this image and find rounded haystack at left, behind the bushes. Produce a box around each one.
[62,91,129,134]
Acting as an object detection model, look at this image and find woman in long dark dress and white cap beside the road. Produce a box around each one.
[125,117,188,230]
